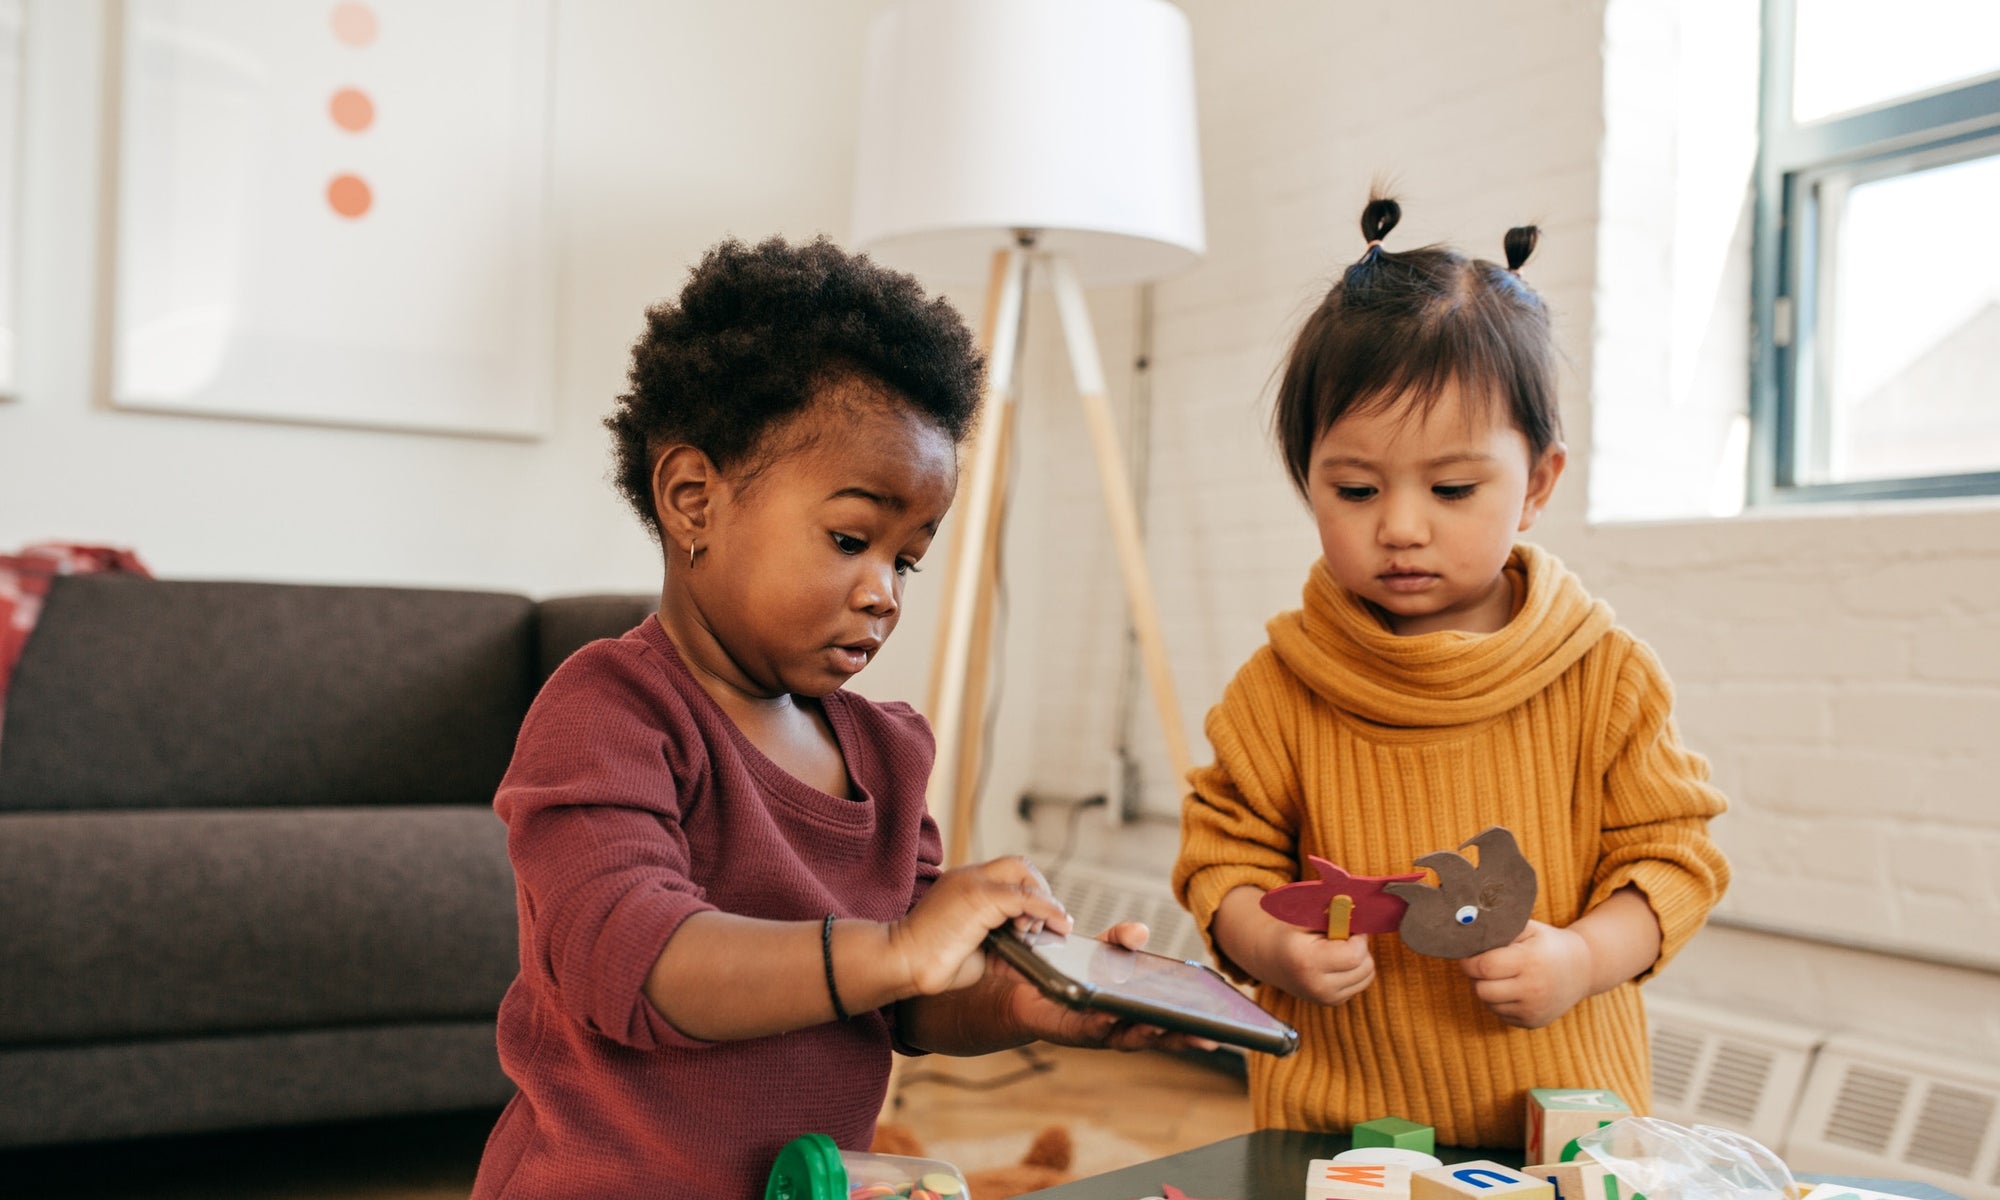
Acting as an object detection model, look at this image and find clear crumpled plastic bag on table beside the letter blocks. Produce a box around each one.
[1576,1116,1798,1200]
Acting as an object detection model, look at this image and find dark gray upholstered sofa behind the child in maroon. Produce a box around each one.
[0,576,654,1146]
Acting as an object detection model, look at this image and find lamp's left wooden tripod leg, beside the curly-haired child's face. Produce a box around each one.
[924,250,1028,866]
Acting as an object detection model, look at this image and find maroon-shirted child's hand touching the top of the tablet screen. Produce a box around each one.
[888,856,1070,996]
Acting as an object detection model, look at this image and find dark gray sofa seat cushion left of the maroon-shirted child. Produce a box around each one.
[0,806,518,1044]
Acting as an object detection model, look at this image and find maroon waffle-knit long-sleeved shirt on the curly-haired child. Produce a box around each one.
[472,616,942,1200]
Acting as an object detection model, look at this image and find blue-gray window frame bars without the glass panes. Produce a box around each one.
[1746,0,2000,506]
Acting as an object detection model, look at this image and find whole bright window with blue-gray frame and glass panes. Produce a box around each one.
[1750,0,2000,502]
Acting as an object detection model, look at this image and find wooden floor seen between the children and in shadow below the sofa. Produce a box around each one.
[0,1046,1252,1200]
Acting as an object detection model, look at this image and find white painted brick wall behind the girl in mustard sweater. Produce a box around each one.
[1008,0,2000,1060]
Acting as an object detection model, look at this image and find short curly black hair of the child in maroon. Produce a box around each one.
[604,238,980,536]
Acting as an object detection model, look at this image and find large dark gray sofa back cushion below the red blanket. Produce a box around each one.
[0,576,540,810]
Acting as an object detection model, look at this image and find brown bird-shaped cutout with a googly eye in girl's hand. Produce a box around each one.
[1382,826,1536,958]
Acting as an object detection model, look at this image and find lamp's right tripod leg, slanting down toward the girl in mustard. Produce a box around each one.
[1048,254,1194,788]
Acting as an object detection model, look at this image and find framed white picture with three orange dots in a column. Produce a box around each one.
[110,0,554,438]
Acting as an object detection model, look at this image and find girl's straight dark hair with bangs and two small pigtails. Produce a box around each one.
[1272,196,1562,494]
